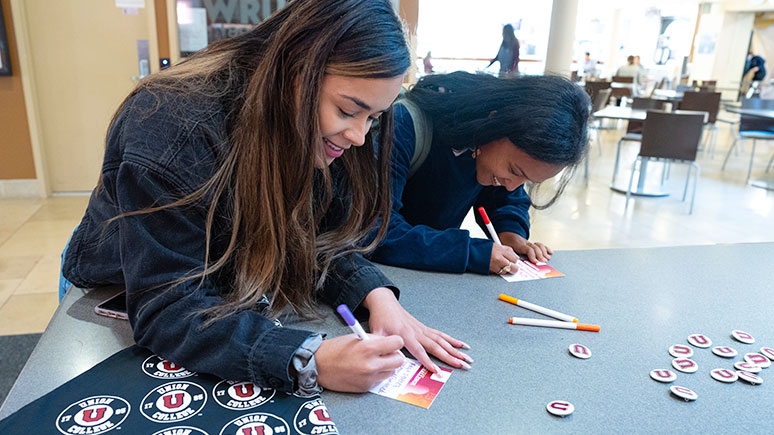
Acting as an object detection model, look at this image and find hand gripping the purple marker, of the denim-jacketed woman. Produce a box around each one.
[314,334,404,393]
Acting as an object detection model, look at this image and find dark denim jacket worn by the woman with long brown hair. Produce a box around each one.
[63,87,396,392]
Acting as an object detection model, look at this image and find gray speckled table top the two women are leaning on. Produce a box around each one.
[0,243,774,434]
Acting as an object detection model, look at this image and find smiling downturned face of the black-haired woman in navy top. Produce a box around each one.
[476,138,563,191]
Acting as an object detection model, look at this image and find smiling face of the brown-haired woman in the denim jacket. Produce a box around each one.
[318,75,410,166]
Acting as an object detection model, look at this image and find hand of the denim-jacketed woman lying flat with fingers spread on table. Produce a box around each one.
[363,287,473,373]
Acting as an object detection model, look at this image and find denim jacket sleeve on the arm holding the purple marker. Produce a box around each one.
[117,158,322,392]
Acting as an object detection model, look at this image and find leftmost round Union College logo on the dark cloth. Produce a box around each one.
[56,396,131,435]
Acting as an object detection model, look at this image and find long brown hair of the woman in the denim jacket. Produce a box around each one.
[111,0,411,320]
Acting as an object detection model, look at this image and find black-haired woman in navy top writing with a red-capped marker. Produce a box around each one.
[370,72,590,274]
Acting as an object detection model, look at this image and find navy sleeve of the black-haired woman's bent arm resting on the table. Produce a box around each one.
[369,105,492,274]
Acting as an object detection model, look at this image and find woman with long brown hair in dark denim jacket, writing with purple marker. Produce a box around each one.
[64,0,471,396]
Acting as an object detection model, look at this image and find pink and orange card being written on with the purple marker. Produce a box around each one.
[370,358,452,409]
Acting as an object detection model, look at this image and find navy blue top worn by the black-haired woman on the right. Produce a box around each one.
[369,104,530,274]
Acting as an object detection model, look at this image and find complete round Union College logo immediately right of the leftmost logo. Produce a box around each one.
[140,381,207,423]
